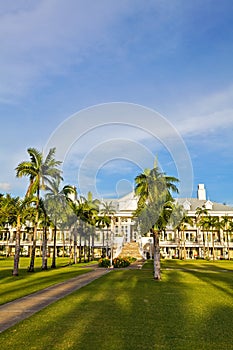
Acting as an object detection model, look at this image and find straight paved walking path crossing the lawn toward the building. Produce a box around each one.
[0,268,111,333]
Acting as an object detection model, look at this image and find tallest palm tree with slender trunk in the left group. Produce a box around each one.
[16,148,62,272]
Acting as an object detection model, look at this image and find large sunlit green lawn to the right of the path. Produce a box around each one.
[0,260,233,350]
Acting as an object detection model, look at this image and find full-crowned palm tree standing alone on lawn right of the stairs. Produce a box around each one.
[135,162,178,280]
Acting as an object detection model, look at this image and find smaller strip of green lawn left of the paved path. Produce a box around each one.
[0,258,96,305]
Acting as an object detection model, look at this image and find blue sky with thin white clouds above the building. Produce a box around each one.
[0,0,233,204]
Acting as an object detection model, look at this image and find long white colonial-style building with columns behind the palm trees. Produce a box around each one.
[0,184,233,259]
